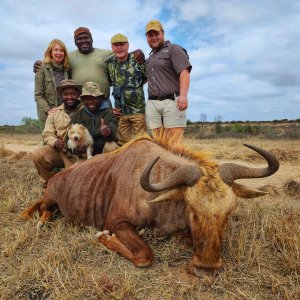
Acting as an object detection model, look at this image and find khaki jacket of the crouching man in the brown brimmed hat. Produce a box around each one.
[42,104,82,147]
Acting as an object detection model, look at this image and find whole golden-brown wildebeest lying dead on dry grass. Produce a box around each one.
[23,136,279,275]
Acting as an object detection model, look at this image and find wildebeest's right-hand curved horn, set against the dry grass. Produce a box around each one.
[219,144,279,185]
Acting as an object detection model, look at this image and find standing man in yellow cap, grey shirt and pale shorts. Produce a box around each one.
[146,20,192,143]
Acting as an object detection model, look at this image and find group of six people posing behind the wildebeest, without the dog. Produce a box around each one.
[33,20,192,184]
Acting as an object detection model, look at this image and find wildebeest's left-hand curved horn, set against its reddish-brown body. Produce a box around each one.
[140,156,202,192]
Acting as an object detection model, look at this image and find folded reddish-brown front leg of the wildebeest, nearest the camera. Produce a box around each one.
[96,223,153,267]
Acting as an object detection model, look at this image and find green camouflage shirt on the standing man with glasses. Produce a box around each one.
[108,53,146,115]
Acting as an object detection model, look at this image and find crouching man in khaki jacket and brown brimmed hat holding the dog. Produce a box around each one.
[33,79,82,186]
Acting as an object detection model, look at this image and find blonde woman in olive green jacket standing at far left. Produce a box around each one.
[34,39,69,131]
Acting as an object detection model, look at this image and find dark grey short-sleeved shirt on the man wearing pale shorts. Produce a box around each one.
[146,41,192,96]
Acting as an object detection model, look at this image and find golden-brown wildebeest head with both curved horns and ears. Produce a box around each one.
[140,145,279,276]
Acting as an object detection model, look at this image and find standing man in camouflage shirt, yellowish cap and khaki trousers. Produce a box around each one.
[108,33,147,145]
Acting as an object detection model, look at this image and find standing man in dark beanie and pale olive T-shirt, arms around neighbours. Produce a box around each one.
[34,27,144,107]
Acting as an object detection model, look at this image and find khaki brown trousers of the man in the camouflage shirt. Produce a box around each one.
[117,114,147,145]
